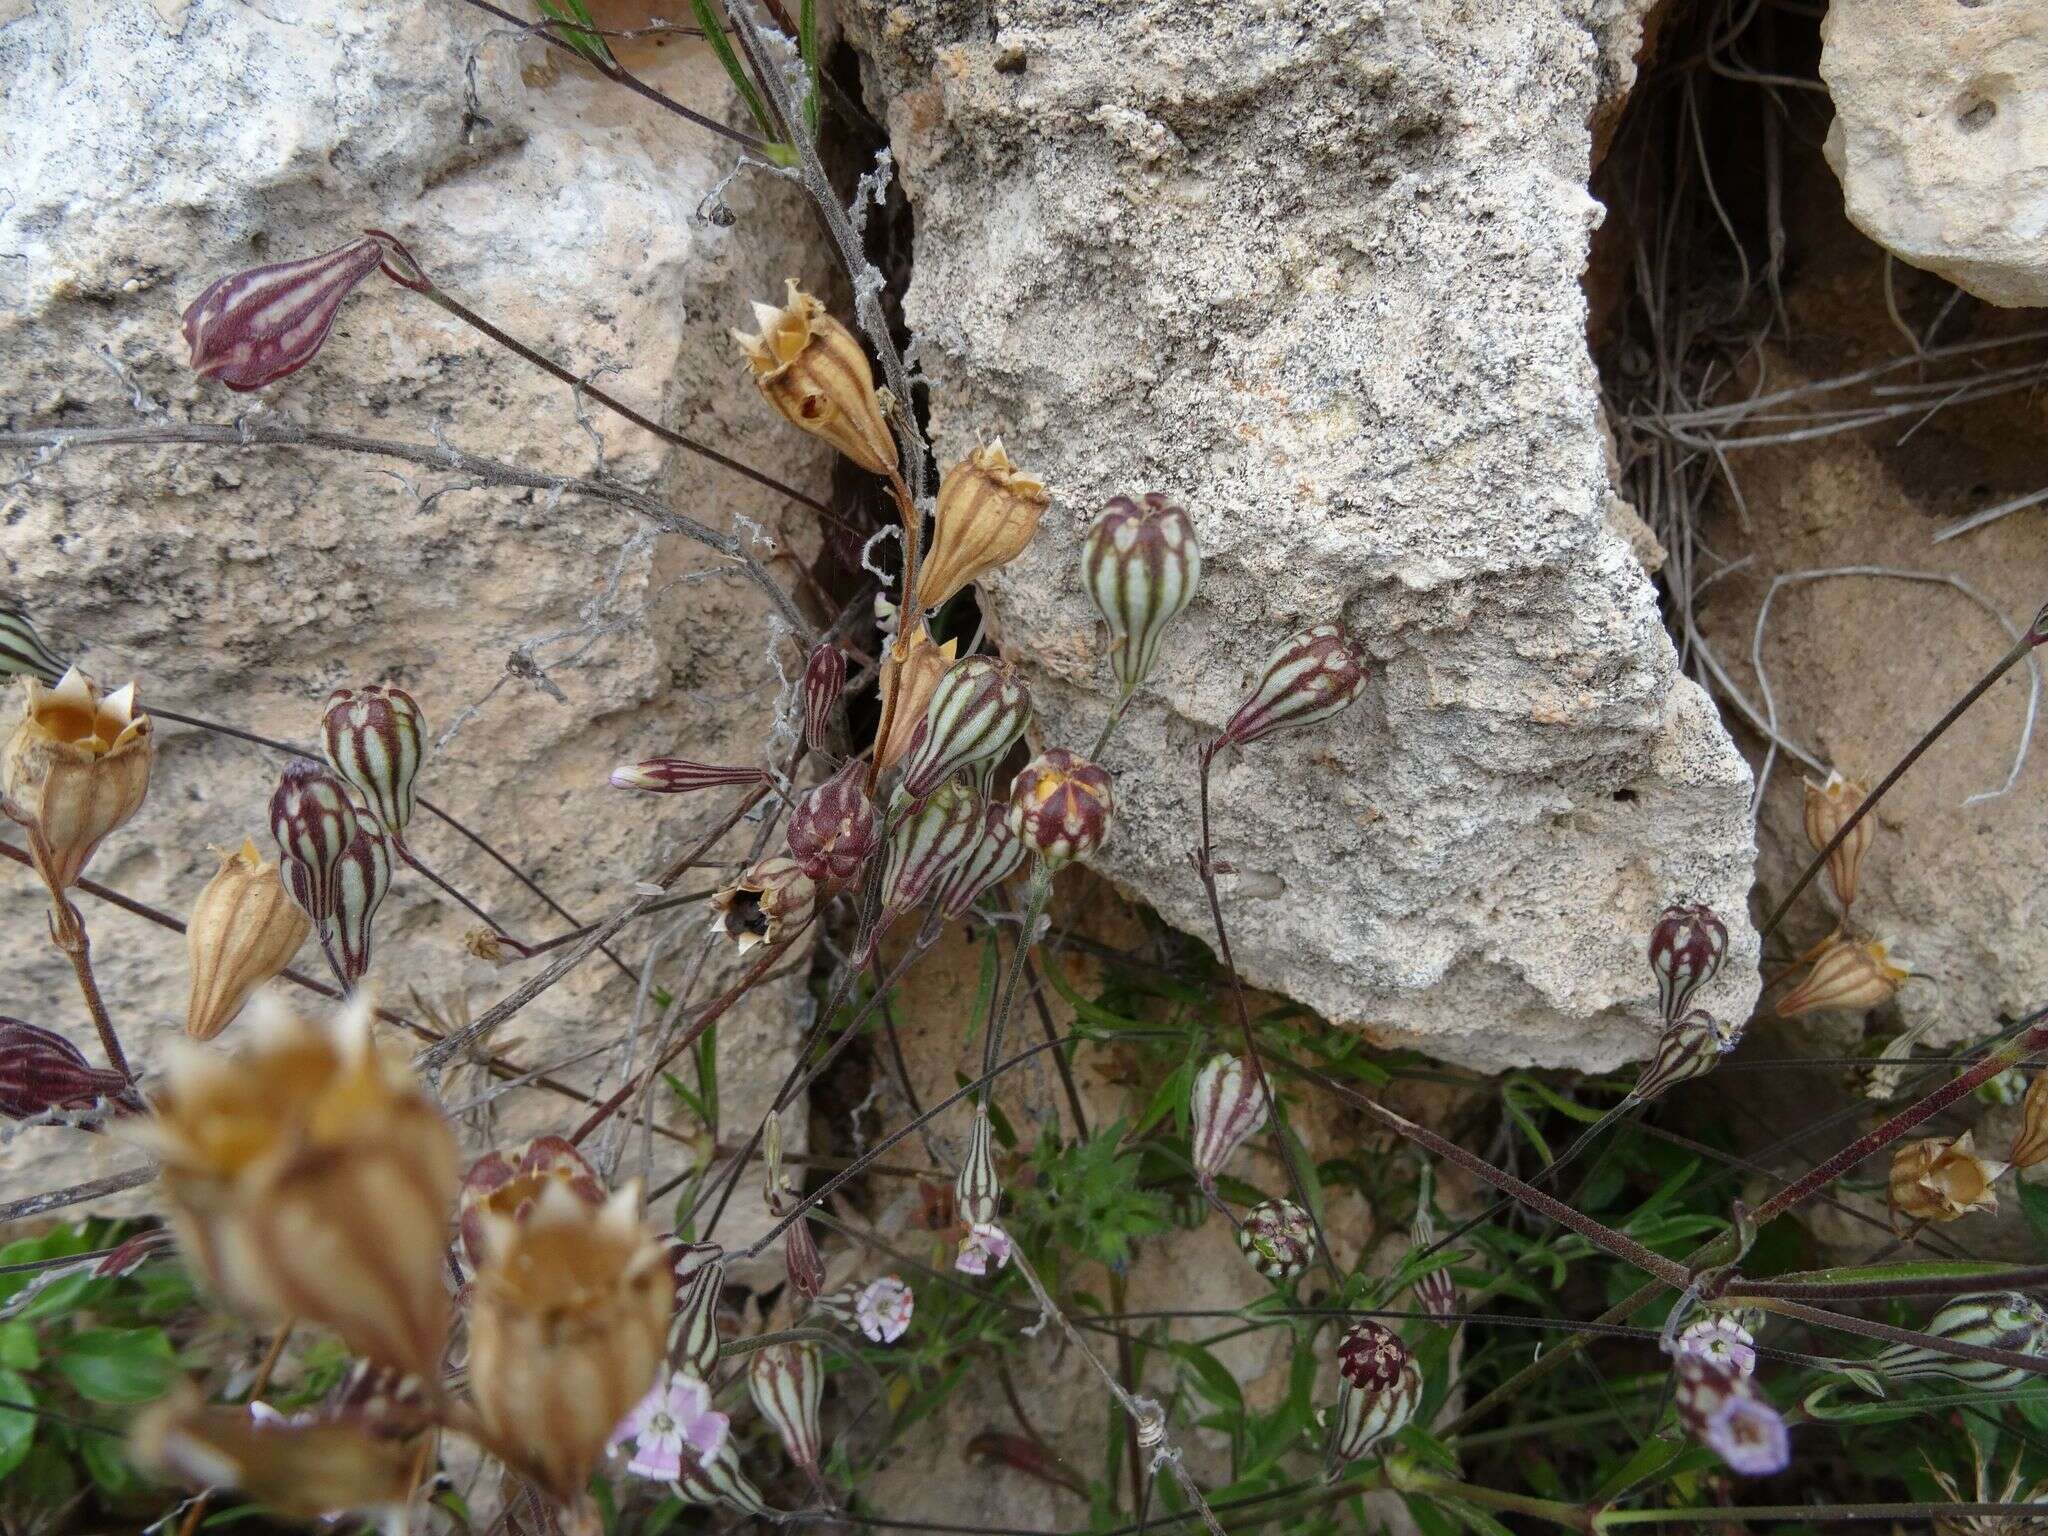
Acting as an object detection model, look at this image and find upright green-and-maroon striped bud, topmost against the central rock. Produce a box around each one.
[1081,492,1202,694]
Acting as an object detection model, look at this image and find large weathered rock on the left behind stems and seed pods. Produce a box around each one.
[0,0,827,1236]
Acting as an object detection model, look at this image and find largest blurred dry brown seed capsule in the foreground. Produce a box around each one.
[135,1006,464,1376]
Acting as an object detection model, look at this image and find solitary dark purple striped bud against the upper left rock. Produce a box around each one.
[184,236,383,391]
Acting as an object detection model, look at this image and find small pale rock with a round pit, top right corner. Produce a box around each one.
[1821,0,2048,305]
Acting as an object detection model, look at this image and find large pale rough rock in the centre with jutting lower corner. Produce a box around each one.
[852,0,1755,1067]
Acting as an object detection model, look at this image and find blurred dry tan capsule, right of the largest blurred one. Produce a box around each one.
[469,1182,676,1503]
